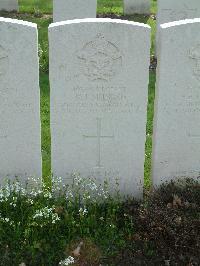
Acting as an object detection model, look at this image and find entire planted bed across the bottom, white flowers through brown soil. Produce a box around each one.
[0,176,200,266]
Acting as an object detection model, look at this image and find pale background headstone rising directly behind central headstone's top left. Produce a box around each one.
[53,0,97,22]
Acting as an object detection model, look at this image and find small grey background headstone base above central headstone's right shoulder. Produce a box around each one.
[123,0,151,15]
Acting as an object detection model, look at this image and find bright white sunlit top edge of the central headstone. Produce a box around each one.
[49,18,151,30]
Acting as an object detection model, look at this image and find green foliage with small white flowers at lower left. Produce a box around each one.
[0,174,133,265]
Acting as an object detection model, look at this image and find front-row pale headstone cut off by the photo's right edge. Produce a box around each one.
[152,19,200,185]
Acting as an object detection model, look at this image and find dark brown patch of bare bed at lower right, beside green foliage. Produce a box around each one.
[111,180,200,266]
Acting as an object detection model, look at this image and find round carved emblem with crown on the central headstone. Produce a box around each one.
[77,34,122,81]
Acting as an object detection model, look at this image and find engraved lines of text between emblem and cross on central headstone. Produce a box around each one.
[62,86,135,113]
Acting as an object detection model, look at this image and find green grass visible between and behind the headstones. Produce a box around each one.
[3,0,156,187]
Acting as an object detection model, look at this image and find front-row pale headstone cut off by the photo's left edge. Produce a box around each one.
[0,18,41,181]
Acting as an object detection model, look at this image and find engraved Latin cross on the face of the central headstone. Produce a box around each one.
[83,118,114,168]
